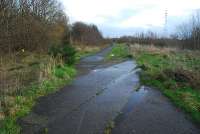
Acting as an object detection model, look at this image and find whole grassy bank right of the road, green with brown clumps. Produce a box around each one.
[131,45,200,123]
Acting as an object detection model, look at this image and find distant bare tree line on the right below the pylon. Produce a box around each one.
[113,11,200,50]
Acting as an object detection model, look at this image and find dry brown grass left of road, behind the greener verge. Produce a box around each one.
[0,53,63,120]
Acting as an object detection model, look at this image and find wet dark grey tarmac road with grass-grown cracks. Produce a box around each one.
[18,47,200,134]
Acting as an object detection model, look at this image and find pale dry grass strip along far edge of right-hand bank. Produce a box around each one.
[131,44,200,69]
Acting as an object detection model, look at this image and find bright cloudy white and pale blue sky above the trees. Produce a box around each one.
[61,0,200,37]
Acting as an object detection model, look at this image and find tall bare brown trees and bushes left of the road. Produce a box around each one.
[0,0,103,53]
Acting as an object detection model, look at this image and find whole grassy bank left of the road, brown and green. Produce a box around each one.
[0,53,76,134]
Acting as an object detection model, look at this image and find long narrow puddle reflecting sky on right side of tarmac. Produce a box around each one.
[114,86,148,126]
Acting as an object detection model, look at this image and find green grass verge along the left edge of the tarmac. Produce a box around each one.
[0,55,76,134]
